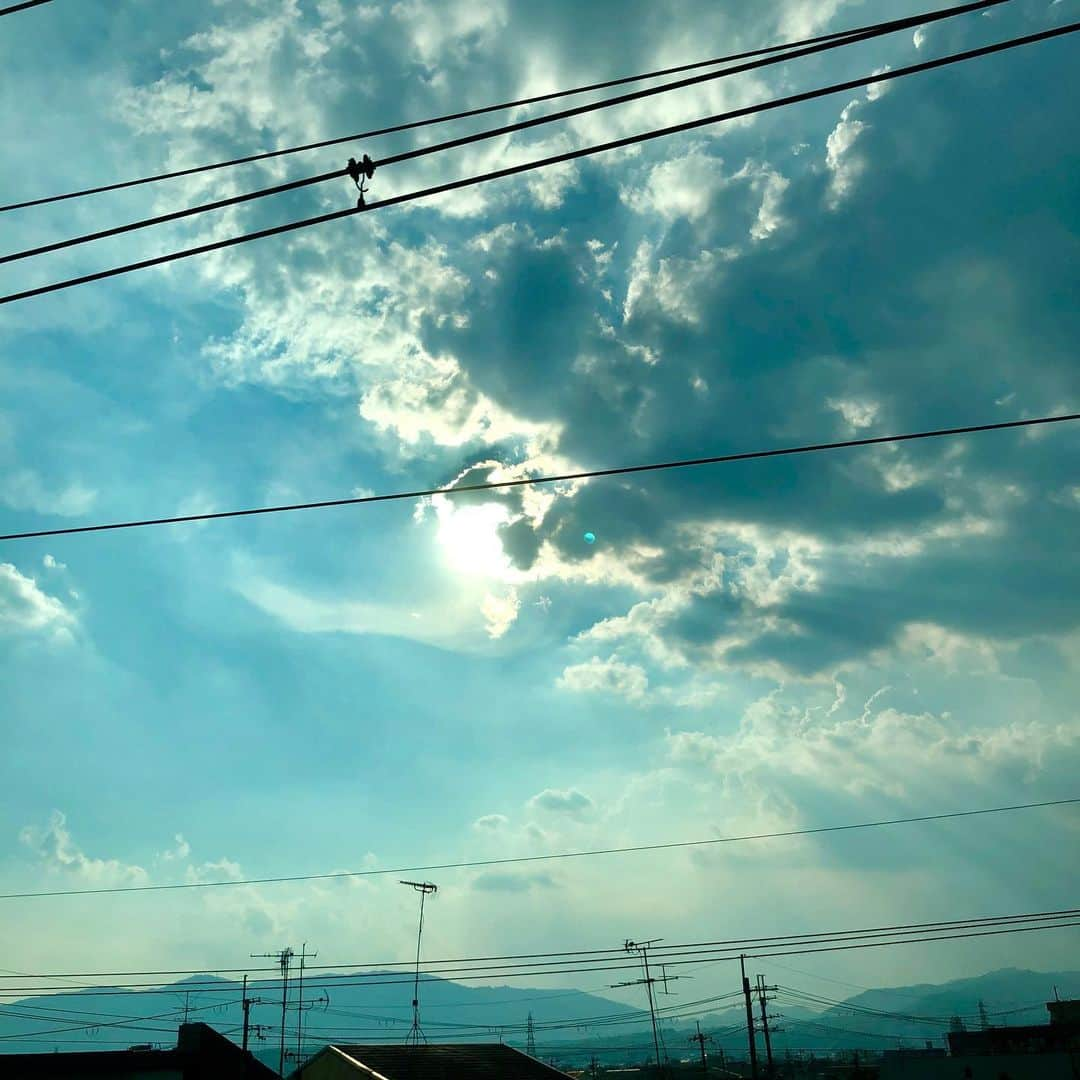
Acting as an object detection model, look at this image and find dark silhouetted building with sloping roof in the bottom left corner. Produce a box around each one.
[0,1024,278,1080]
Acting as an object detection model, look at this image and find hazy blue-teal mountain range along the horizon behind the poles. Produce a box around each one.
[0,968,1080,1066]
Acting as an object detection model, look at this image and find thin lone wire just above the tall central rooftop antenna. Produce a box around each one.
[0,794,1080,900]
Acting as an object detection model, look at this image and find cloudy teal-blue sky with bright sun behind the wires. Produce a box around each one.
[0,0,1080,1010]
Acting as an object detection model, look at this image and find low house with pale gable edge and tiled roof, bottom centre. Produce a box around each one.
[292,1043,566,1080]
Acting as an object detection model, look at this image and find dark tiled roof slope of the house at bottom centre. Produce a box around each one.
[329,1043,566,1080]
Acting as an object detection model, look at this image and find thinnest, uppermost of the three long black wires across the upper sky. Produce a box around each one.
[0,0,1003,214]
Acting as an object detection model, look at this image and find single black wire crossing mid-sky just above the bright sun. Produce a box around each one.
[0,413,1080,548]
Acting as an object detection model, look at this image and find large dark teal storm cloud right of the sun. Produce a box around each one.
[408,2,1080,673]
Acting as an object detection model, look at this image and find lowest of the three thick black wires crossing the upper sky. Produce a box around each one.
[0,23,1080,305]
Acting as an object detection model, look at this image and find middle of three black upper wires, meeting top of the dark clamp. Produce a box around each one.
[0,0,1010,265]
